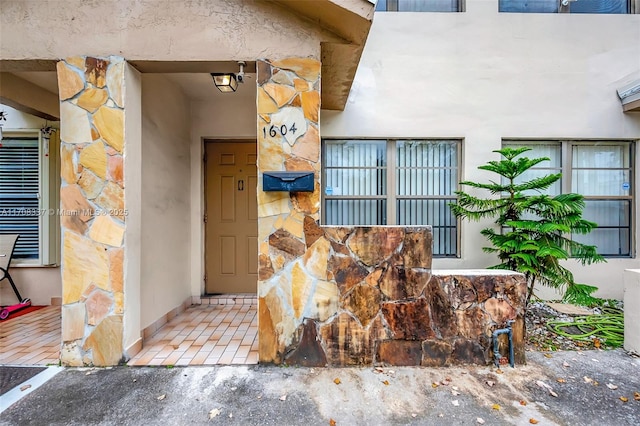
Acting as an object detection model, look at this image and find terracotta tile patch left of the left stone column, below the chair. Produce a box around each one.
[0,306,60,365]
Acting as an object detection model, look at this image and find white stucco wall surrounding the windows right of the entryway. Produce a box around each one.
[321,0,640,299]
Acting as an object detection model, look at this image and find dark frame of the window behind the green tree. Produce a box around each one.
[502,138,638,259]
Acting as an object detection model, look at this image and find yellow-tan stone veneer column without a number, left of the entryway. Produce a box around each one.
[57,57,127,366]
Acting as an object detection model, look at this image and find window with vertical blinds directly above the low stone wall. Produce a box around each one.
[323,139,460,257]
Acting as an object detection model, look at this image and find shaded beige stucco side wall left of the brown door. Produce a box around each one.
[140,74,191,328]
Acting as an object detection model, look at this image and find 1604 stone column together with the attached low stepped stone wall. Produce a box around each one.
[257,58,526,366]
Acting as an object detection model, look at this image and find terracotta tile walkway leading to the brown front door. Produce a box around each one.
[128,304,258,365]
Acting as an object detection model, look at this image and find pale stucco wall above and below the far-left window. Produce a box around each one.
[0,104,62,306]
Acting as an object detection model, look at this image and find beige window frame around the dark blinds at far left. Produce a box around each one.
[0,129,61,267]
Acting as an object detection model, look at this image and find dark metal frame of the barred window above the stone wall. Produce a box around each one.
[320,137,463,259]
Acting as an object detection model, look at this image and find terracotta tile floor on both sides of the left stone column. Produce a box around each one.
[0,301,258,366]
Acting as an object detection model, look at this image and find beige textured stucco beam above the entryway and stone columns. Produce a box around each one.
[0,0,339,61]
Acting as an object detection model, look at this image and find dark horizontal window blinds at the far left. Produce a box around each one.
[0,138,40,259]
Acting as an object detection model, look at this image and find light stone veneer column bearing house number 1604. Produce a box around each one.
[257,58,324,363]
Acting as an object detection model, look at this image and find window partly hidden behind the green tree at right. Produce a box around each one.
[503,141,634,257]
